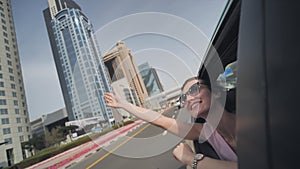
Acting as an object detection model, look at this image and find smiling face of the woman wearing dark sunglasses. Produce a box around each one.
[182,79,211,118]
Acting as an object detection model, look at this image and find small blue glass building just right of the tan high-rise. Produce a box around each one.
[138,62,164,97]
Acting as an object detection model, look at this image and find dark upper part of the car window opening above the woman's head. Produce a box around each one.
[198,0,240,80]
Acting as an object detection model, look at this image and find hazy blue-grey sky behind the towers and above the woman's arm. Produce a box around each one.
[11,0,226,121]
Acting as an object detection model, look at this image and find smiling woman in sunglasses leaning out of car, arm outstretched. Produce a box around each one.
[105,77,237,169]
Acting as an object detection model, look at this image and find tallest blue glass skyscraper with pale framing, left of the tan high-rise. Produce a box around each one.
[43,0,114,126]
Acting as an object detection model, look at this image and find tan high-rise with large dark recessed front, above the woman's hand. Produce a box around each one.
[103,42,148,105]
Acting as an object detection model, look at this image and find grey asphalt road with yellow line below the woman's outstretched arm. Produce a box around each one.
[68,108,186,169]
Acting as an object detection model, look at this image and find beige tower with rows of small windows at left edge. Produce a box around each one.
[0,0,31,168]
